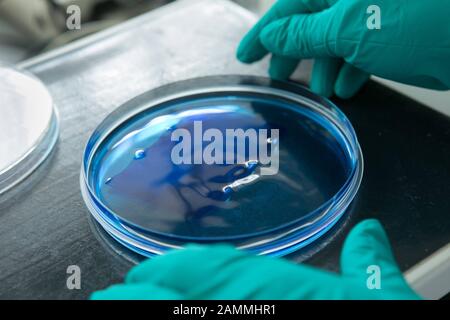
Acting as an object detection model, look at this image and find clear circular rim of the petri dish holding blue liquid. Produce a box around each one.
[80,76,363,255]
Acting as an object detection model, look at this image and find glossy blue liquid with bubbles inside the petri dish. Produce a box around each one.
[90,96,351,238]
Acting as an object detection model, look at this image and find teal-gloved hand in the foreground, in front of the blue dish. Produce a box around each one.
[91,220,419,299]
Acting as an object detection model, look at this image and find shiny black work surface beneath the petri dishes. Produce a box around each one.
[0,0,450,299]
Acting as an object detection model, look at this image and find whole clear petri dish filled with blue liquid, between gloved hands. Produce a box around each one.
[80,76,363,257]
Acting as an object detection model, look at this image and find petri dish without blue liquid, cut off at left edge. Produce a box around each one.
[0,65,58,195]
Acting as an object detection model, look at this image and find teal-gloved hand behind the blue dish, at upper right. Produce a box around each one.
[237,0,450,98]
